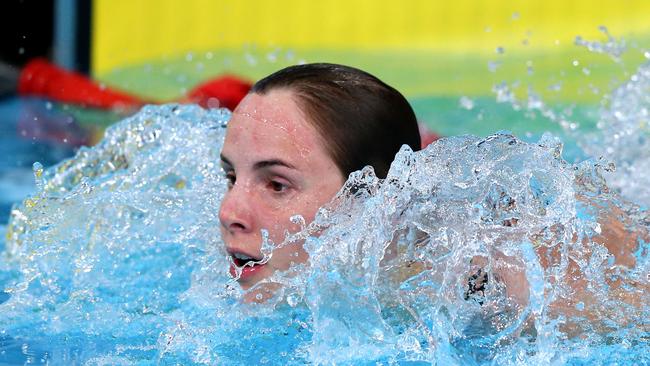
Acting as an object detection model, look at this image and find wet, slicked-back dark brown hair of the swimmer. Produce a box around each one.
[251,63,420,178]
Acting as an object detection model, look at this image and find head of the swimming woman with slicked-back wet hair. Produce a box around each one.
[219,63,421,289]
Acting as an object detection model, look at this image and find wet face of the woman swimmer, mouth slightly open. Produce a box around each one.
[219,89,344,289]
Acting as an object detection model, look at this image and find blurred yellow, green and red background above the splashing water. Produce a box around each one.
[0,0,650,221]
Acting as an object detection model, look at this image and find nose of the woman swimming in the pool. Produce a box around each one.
[219,183,253,234]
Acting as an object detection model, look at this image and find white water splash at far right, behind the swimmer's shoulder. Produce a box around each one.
[492,27,650,207]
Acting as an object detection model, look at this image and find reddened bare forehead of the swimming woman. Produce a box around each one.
[223,89,324,160]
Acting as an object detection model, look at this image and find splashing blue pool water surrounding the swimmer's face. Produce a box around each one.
[0,65,650,365]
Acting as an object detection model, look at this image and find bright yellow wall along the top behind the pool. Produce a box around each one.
[92,0,650,74]
